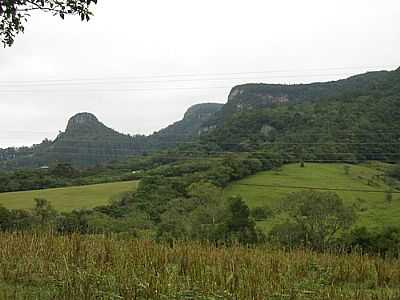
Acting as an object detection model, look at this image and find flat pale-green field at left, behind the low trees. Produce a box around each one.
[0,181,137,212]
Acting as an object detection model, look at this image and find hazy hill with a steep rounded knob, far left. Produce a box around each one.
[2,113,145,168]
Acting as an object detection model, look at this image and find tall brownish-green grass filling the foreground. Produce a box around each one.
[0,233,400,300]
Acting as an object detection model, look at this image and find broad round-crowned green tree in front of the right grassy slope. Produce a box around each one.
[271,191,356,250]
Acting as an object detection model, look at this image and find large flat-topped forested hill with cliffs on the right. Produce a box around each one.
[203,69,400,161]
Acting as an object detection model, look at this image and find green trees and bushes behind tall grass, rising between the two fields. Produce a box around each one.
[0,152,400,256]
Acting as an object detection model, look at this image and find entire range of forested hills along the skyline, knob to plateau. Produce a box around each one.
[0,68,400,169]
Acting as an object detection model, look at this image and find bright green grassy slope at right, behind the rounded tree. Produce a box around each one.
[225,163,400,230]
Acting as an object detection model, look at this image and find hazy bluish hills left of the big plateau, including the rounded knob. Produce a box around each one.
[0,103,223,169]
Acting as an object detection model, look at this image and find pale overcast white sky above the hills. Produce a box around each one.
[0,0,400,148]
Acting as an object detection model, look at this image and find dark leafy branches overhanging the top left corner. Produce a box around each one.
[0,0,97,47]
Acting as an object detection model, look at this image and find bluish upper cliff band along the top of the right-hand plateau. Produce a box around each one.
[207,68,400,126]
